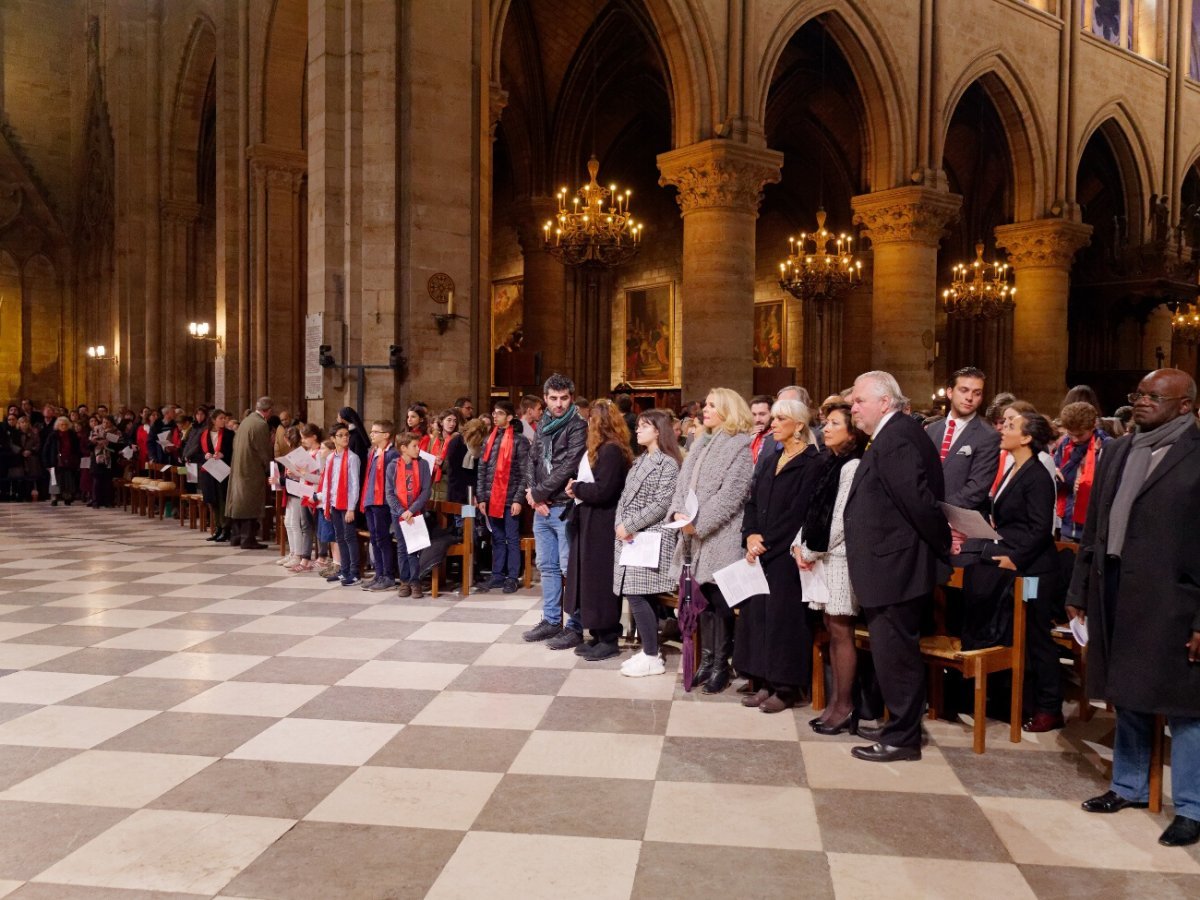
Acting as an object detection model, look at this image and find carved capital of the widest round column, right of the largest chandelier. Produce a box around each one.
[658,139,784,216]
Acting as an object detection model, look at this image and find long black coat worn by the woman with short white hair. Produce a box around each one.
[733,445,824,688]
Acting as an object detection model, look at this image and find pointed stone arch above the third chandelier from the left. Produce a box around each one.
[934,48,1050,222]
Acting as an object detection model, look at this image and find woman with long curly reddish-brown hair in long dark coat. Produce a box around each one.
[563,400,634,662]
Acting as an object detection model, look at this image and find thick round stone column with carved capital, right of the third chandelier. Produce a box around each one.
[996,218,1092,416]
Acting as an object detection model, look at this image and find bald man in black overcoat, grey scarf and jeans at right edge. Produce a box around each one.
[1067,368,1200,847]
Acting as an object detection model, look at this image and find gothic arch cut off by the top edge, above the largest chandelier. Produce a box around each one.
[491,0,720,146]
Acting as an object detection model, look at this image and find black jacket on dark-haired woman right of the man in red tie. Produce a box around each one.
[980,456,1058,575]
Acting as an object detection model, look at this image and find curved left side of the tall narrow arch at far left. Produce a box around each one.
[167,16,217,203]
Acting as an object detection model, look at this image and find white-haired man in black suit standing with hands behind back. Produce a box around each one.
[845,372,950,762]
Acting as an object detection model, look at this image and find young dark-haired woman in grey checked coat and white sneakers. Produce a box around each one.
[612,409,683,678]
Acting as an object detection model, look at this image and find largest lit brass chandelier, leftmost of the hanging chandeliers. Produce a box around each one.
[542,156,644,269]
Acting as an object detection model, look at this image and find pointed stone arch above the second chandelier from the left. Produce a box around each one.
[754,0,916,192]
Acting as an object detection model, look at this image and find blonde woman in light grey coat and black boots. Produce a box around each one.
[667,388,754,694]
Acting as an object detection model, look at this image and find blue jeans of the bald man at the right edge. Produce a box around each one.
[1111,709,1200,822]
